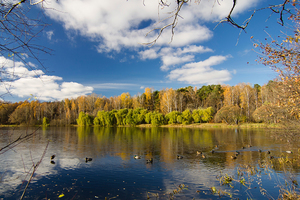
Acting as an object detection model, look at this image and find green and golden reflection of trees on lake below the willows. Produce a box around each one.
[72,127,282,166]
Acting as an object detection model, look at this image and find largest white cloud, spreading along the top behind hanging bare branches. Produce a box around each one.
[45,0,258,52]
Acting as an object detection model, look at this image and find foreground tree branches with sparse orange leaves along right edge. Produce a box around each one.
[254,0,300,123]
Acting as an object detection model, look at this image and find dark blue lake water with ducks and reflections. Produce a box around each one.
[0,127,300,199]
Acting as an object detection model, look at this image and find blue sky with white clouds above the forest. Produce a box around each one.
[0,0,286,102]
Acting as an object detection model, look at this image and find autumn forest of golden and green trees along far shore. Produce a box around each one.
[0,80,298,126]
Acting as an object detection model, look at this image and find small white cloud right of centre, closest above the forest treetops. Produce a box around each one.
[168,56,231,85]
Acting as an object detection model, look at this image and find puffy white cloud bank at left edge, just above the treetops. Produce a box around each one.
[0,57,93,101]
